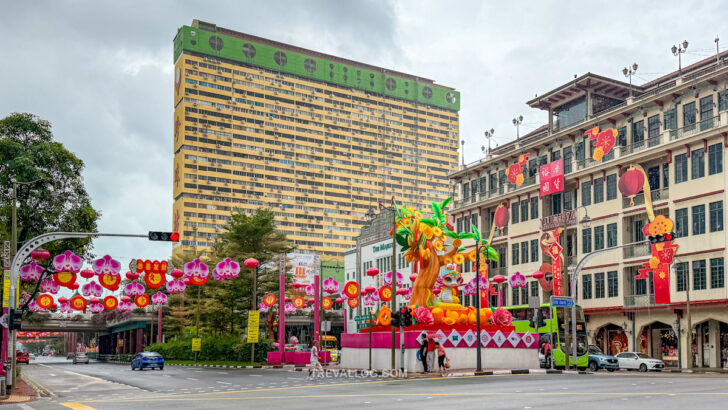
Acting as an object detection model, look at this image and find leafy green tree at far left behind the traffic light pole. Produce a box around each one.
[0,113,101,256]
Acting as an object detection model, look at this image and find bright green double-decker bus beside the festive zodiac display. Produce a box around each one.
[503,303,589,369]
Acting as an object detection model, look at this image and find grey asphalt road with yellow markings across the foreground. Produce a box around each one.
[11,359,728,410]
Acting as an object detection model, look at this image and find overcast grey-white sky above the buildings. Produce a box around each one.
[0,0,728,261]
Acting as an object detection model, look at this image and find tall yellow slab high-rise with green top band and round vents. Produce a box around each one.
[173,20,460,262]
